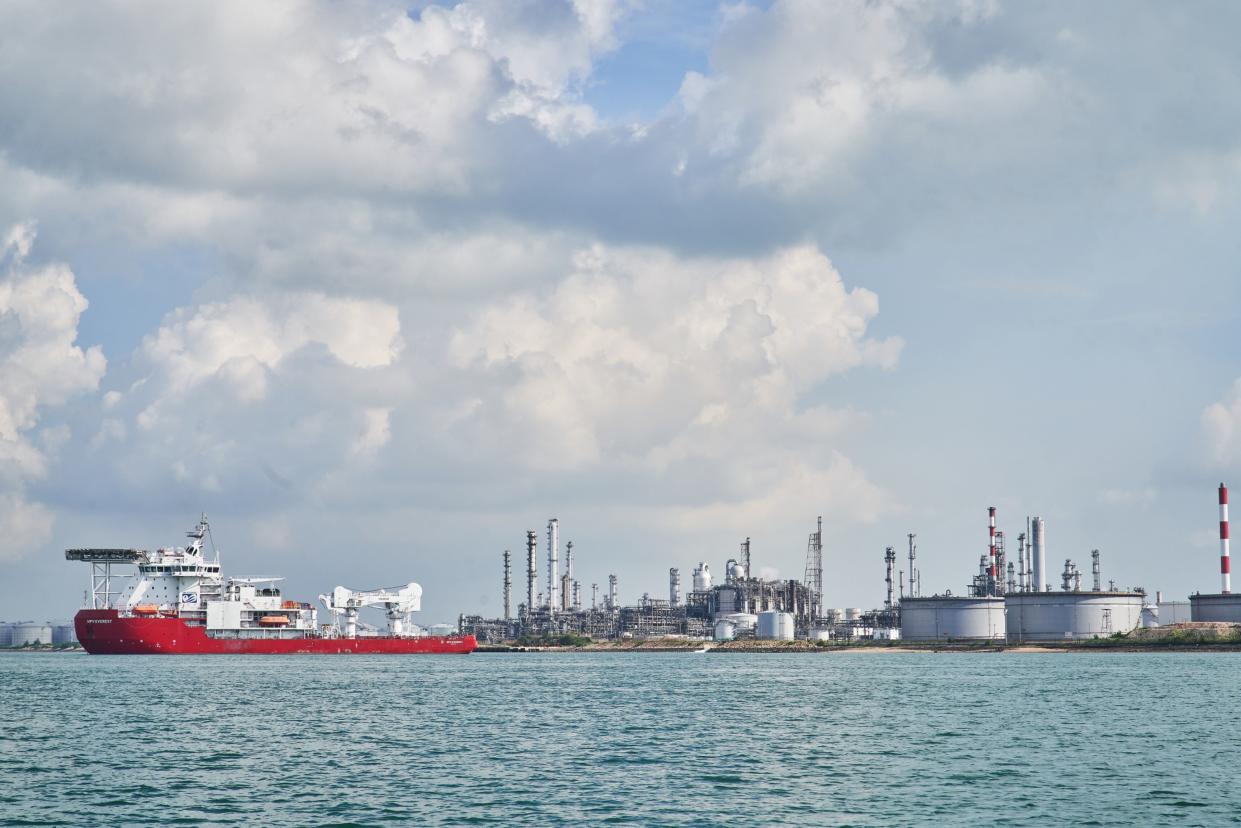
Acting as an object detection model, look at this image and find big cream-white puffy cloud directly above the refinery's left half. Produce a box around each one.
[449,246,902,520]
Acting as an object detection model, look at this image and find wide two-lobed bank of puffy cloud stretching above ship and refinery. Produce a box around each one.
[62,245,902,530]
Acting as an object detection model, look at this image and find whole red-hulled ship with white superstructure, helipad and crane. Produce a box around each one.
[65,516,478,655]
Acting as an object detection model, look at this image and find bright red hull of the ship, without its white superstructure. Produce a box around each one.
[73,610,478,655]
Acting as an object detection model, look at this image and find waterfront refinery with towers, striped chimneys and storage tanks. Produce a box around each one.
[458,483,1241,643]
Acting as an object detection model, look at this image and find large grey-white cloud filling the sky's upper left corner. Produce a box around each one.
[0,0,624,195]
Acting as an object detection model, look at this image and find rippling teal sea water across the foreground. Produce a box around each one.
[0,653,1241,827]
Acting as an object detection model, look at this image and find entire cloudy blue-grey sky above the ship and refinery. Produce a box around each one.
[0,0,1241,623]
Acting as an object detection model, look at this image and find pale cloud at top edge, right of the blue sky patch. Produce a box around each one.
[680,0,1046,190]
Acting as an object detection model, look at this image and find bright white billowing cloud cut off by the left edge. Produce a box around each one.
[0,223,107,560]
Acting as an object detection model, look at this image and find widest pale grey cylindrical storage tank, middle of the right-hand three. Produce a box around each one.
[1006,592,1145,641]
